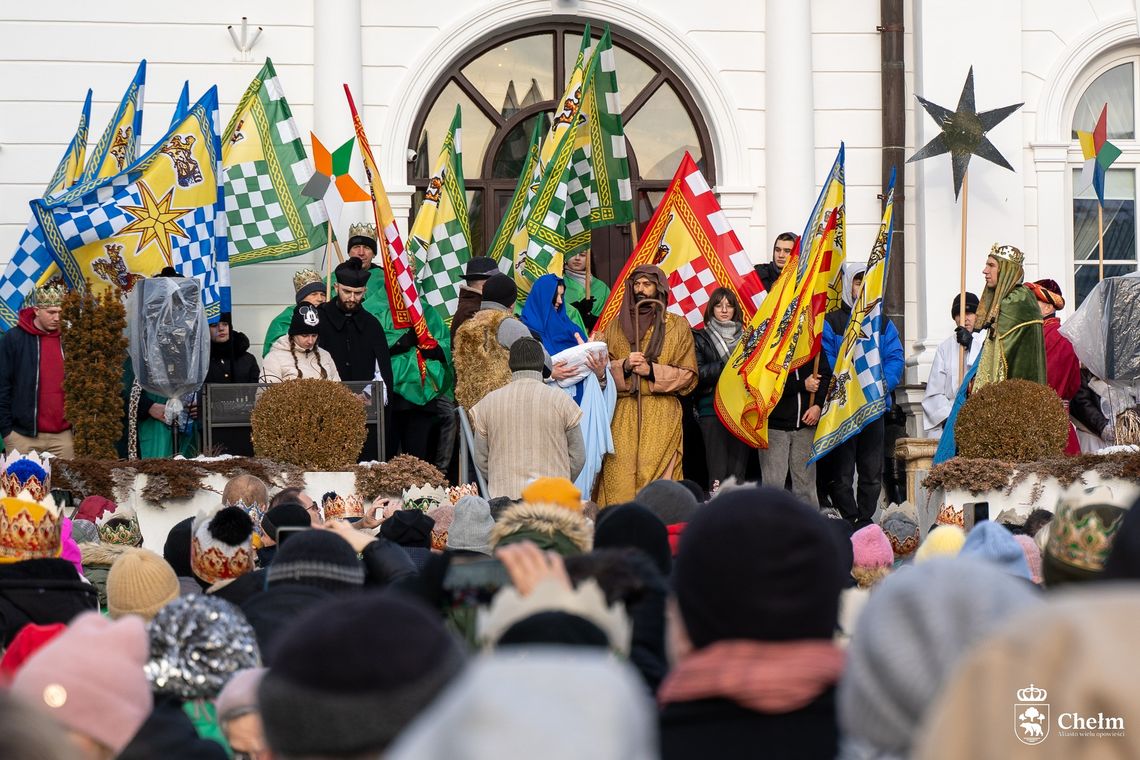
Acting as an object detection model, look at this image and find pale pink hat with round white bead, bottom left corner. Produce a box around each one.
[11,612,154,755]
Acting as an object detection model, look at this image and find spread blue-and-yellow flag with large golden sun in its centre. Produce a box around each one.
[32,88,230,322]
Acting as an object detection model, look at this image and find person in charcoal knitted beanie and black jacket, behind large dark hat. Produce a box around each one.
[242,530,365,664]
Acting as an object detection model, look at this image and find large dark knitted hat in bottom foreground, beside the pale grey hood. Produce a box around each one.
[258,591,463,757]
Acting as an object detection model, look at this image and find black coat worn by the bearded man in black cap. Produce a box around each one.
[317,299,396,391]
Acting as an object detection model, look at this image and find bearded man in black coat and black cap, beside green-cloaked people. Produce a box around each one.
[317,259,394,460]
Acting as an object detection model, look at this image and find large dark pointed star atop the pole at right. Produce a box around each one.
[906,66,1025,201]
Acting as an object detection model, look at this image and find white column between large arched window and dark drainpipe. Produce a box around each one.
[756,0,819,242]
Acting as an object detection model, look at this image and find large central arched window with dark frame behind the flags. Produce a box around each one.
[408,21,716,288]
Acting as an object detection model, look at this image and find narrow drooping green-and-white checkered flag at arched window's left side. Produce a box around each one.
[408,106,471,327]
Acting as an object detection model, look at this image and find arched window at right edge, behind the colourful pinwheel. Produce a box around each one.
[1067,58,1140,307]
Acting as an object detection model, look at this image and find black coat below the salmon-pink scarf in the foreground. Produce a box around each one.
[659,688,839,760]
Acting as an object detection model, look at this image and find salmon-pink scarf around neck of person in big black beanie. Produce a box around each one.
[657,639,845,713]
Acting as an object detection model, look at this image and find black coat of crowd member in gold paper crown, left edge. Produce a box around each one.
[0,559,99,647]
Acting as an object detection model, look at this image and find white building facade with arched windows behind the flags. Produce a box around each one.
[0,0,1140,428]
